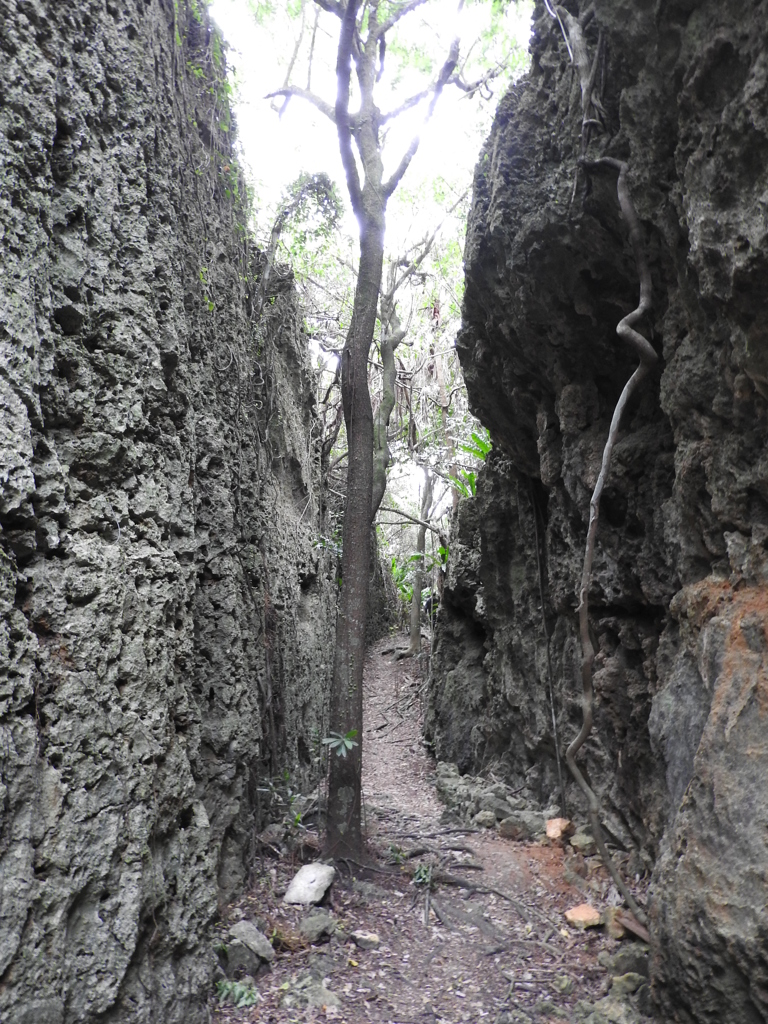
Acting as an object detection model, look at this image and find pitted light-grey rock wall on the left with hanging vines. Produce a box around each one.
[0,0,335,1024]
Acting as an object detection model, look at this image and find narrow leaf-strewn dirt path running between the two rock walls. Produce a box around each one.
[214,641,651,1024]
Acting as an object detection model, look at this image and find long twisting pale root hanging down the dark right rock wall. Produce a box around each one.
[565,157,657,925]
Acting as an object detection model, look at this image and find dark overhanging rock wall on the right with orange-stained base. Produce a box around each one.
[428,0,768,1024]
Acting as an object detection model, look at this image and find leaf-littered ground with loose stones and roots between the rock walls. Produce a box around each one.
[213,641,649,1024]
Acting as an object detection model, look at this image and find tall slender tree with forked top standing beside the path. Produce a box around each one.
[319,0,466,858]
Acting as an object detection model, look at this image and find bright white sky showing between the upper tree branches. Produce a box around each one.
[210,0,531,248]
